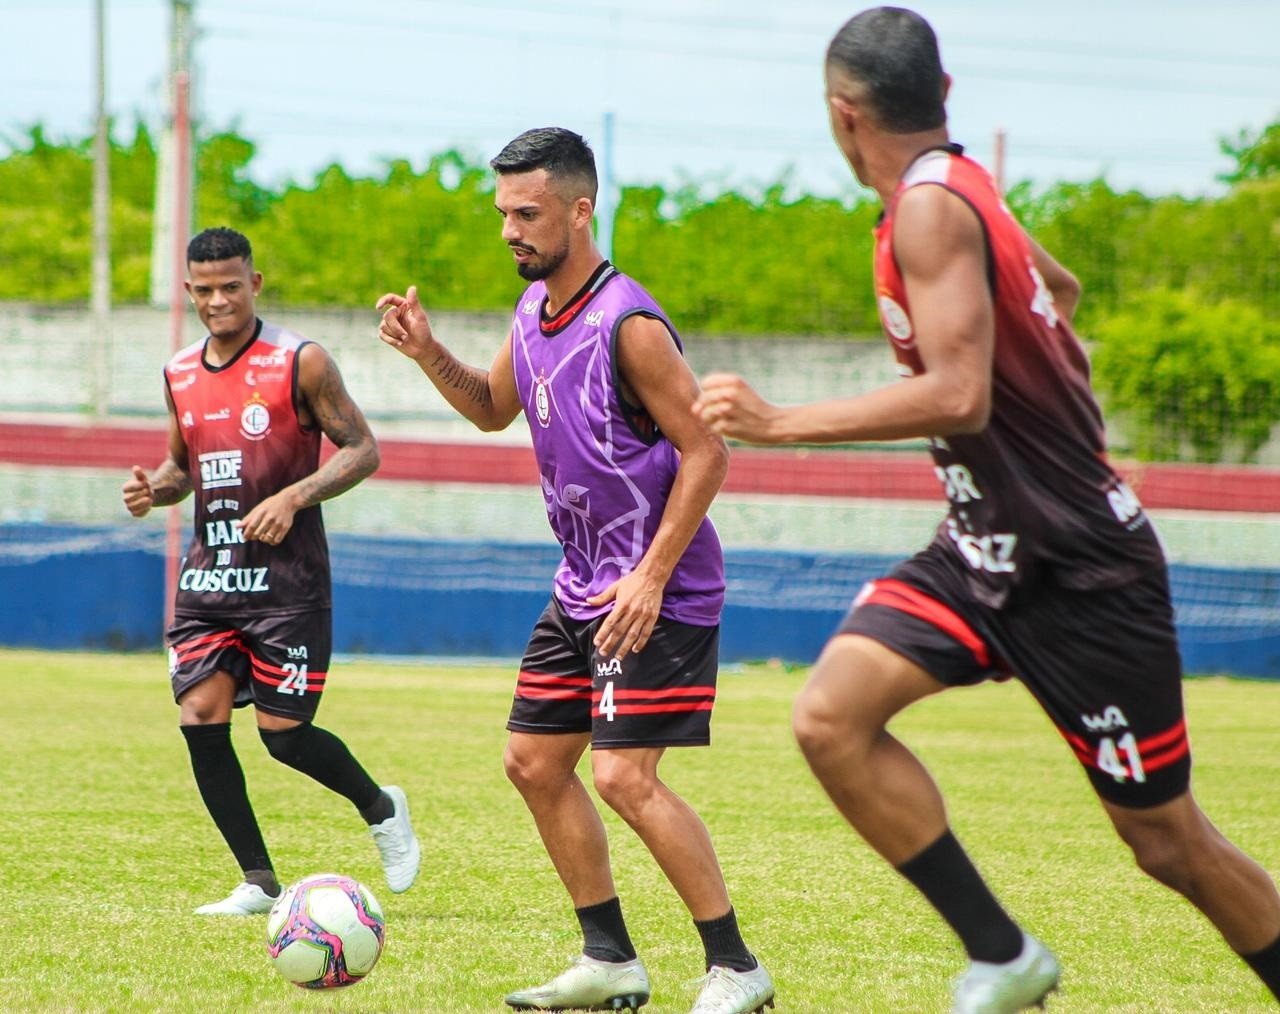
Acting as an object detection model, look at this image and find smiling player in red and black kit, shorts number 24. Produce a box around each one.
[123,228,421,915]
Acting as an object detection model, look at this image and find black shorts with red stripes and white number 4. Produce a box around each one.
[507,598,719,749]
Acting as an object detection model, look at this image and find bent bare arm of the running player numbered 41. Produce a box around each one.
[694,186,995,444]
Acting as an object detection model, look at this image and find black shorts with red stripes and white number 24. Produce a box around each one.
[165,609,333,722]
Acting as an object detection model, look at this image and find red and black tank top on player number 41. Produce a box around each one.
[876,146,1164,607]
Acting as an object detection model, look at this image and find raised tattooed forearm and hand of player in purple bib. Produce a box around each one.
[376,286,520,431]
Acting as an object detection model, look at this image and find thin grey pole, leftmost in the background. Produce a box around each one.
[90,0,111,419]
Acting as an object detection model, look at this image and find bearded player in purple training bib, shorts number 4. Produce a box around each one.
[378,128,773,1014]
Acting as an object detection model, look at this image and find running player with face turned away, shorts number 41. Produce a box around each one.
[695,8,1280,1011]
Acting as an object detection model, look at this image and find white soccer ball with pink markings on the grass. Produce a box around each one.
[266,873,387,990]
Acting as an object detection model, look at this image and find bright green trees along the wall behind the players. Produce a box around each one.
[0,122,1280,460]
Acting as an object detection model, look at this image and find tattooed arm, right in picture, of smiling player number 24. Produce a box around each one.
[241,343,379,543]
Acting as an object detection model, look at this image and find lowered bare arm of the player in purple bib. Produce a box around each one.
[590,315,728,657]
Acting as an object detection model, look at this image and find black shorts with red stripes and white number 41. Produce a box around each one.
[838,543,1192,807]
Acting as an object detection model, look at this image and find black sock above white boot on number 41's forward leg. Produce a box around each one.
[897,830,1023,964]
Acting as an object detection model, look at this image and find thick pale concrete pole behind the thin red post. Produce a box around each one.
[151,0,195,306]
